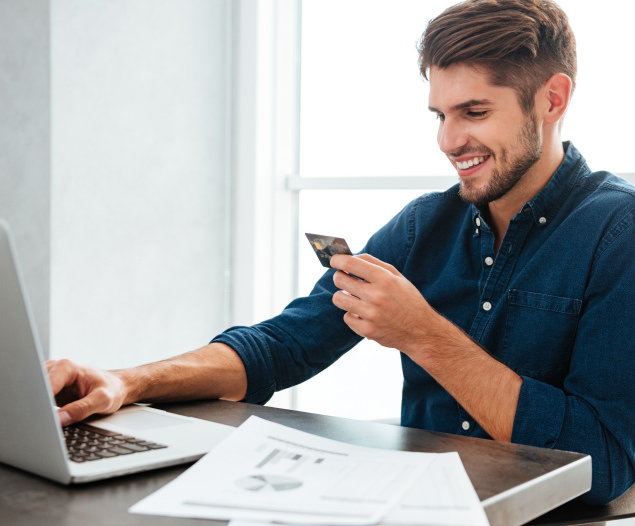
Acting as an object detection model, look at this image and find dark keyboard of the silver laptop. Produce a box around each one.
[63,424,167,462]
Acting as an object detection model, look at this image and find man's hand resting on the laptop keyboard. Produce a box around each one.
[46,360,125,426]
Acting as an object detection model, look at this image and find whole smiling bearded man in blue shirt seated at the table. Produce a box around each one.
[48,0,635,503]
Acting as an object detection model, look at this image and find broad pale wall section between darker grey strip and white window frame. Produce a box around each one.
[51,0,232,368]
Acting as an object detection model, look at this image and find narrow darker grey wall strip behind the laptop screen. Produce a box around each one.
[0,0,50,349]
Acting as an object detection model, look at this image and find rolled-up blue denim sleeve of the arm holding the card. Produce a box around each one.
[512,210,635,504]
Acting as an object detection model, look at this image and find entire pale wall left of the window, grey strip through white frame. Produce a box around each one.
[0,0,299,374]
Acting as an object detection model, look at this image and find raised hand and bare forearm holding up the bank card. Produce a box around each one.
[331,254,522,441]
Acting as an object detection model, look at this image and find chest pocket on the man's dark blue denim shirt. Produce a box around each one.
[500,289,582,385]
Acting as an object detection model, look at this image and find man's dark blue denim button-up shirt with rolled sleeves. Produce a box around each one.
[215,143,635,503]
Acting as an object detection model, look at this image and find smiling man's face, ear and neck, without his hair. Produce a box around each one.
[430,63,572,247]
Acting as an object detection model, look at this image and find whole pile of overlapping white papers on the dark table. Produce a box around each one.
[130,417,488,526]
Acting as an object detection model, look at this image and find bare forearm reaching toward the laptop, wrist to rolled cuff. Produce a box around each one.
[114,343,247,404]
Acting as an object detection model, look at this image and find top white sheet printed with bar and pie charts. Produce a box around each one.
[130,416,436,525]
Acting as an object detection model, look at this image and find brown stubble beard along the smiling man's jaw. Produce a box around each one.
[459,115,542,208]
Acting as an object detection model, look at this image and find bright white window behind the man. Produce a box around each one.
[276,0,635,418]
